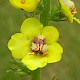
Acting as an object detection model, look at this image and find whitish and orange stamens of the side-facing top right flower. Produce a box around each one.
[63,0,77,15]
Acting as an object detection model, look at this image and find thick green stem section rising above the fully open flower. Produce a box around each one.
[40,0,50,26]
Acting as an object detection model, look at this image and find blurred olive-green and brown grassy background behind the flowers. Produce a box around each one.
[0,0,80,80]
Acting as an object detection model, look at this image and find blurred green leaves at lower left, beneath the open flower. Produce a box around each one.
[7,59,31,75]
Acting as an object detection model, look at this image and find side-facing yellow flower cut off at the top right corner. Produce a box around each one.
[59,0,80,24]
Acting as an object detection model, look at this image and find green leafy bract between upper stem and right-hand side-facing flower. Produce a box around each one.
[50,2,67,21]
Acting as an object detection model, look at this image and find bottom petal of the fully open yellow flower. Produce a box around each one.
[22,54,47,70]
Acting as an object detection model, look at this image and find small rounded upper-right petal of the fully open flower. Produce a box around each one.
[42,26,59,44]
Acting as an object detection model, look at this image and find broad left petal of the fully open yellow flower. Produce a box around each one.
[8,33,30,59]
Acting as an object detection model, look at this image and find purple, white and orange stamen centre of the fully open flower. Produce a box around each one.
[31,35,48,56]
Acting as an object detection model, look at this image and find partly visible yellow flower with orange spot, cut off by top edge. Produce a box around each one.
[9,0,40,12]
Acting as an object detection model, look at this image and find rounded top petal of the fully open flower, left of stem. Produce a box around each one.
[21,18,43,39]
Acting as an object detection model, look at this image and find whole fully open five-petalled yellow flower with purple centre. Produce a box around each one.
[8,18,63,70]
